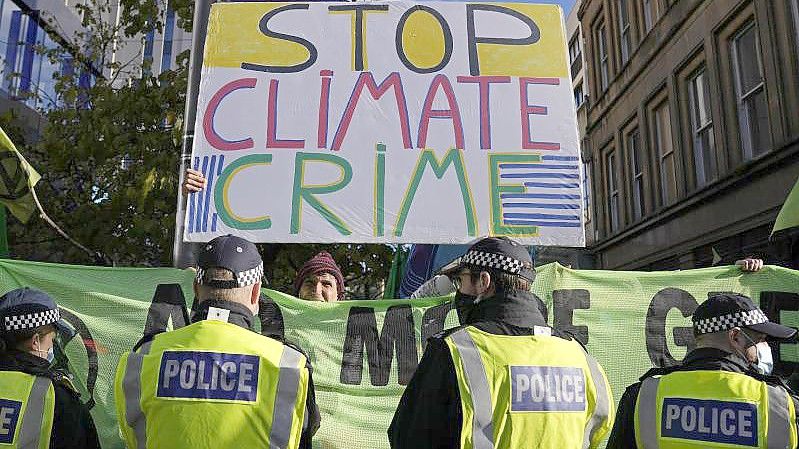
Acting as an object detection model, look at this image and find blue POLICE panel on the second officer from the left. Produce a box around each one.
[156,351,259,402]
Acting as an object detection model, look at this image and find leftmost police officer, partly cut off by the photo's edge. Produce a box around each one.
[0,288,100,449]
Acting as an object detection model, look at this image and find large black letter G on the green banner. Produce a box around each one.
[646,288,698,367]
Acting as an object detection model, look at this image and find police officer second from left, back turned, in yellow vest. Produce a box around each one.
[115,235,319,449]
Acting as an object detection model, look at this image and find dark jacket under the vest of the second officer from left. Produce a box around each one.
[133,300,321,449]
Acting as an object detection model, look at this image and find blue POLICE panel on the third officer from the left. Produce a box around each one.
[510,366,586,412]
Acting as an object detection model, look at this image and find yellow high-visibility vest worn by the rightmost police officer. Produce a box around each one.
[635,370,796,449]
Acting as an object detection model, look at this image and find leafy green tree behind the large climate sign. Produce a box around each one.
[0,0,393,292]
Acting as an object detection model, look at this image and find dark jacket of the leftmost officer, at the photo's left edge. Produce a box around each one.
[0,350,100,449]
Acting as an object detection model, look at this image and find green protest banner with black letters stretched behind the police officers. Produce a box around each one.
[0,260,799,448]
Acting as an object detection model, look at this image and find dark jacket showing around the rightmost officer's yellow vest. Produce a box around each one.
[607,348,799,449]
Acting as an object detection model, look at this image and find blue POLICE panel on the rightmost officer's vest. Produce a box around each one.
[660,398,758,447]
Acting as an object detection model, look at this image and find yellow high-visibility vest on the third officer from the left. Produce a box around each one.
[445,326,613,449]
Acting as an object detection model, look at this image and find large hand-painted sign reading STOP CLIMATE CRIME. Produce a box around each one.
[184,2,584,246]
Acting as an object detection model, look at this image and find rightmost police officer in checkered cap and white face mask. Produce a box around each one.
[607,294,797,449]
